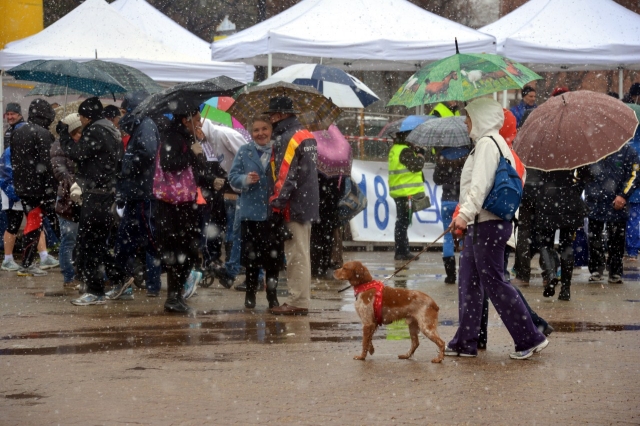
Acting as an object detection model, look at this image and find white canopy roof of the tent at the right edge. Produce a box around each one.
[480,0,640,71]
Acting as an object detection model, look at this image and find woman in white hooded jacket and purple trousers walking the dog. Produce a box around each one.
[445,98,549,359]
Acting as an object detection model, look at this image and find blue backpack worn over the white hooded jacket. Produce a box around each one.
[482,136,522,221]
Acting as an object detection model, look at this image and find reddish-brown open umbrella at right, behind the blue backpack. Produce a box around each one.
[513,90,638,171]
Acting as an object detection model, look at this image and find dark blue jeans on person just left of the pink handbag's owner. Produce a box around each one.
[115,201,162,293]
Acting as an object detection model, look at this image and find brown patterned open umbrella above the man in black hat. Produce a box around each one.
[227,82,342,132]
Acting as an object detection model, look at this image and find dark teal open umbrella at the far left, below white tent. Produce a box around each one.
[7,60,127,100]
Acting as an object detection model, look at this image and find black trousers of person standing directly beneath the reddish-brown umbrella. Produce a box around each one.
[538,228,577,286]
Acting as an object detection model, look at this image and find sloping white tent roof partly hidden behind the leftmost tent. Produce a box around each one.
[111,0,211,62]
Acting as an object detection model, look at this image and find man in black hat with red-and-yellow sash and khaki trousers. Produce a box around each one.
[265,95,319,315]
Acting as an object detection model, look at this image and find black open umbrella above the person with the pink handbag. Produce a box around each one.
[133,75,244,117]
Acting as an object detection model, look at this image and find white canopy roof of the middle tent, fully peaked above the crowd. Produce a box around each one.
[211,0,495,71]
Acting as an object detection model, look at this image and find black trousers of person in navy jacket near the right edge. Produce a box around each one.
[589,219,627,276]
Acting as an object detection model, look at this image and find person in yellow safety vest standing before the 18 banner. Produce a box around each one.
[389,132,424,260]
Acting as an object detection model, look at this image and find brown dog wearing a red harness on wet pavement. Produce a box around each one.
[333,261,444,362]
